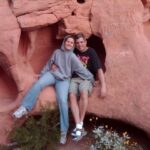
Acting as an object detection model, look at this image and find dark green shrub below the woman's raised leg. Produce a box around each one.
[11,110,59,150]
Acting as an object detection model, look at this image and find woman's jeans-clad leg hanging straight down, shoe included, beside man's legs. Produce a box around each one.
[55,80,70,144]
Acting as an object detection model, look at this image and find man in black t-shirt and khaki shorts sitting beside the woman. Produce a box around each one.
[69,33,106,141]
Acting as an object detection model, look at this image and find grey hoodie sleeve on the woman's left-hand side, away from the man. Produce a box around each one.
[40,52,55,77]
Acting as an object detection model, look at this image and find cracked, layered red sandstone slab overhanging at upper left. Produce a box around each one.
[13,0,75,30]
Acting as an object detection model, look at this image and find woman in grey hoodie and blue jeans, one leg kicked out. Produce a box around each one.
[13,35,93,144]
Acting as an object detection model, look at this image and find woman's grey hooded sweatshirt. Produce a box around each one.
[41,36,94,82]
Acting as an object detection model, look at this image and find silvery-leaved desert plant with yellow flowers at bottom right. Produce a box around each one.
[90,126,130,150]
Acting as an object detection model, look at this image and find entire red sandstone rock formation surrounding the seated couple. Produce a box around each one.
[0,0,150,144]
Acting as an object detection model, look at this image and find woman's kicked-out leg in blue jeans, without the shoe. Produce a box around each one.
[22,72,55,111]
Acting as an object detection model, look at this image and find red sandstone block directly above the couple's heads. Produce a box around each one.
[57,0,93,38]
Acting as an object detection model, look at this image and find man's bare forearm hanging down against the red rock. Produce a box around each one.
[97,68,107,97]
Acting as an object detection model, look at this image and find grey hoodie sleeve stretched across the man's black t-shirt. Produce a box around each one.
[71,54,94,82]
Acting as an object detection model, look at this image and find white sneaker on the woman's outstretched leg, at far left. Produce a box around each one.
[13,106,28,119]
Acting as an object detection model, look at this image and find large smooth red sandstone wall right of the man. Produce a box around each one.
[89,0,150,133]
